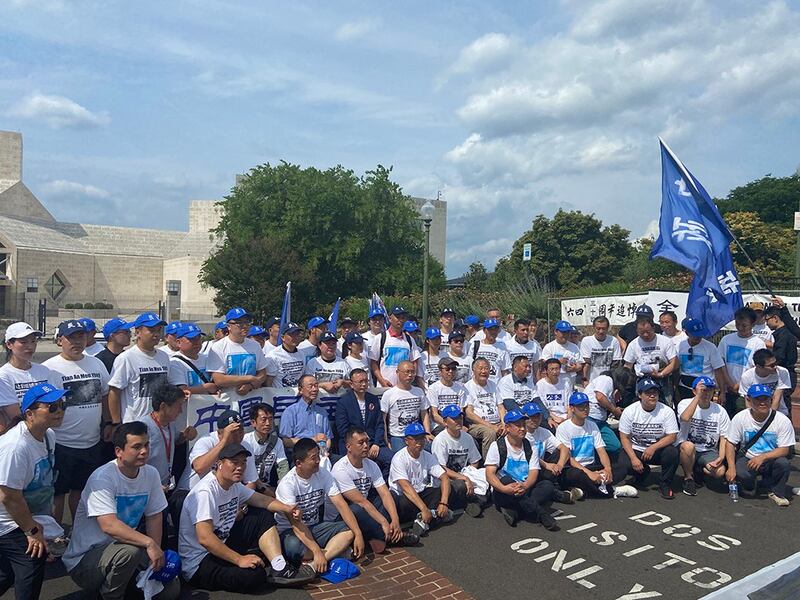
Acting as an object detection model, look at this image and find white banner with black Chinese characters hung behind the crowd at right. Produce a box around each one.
[561,291,800,329]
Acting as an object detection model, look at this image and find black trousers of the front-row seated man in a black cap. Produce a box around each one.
[189,506,275,592]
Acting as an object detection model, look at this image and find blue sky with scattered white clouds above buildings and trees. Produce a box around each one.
[0,0,800,277]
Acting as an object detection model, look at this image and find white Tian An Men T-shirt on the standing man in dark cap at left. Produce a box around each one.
[42,354,109,448]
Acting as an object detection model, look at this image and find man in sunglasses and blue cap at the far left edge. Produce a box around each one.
[0,383,67,599]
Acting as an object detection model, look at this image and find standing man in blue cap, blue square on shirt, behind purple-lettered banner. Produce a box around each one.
[207,307,267,402]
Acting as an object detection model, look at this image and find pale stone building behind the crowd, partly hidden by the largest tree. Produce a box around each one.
[0,131,447,323]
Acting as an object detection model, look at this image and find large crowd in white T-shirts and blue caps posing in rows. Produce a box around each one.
[0,298,800,600]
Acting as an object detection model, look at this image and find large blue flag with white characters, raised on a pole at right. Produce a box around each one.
[650,140,743,335]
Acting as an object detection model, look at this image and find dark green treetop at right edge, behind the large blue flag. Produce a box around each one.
[715,175,800,228]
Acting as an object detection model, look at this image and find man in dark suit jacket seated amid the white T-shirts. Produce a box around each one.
[335,369,394,476]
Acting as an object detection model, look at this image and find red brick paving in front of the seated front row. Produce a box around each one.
[308,548,473,600]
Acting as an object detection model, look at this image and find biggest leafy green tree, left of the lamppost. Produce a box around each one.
[202,162,444,314]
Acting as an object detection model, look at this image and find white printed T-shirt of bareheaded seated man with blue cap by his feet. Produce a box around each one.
[275,468,341,531]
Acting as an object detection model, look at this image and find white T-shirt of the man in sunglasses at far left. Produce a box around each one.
[0,421,56,536]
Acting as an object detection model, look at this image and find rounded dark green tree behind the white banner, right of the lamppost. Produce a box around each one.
[494,210,631,289]
